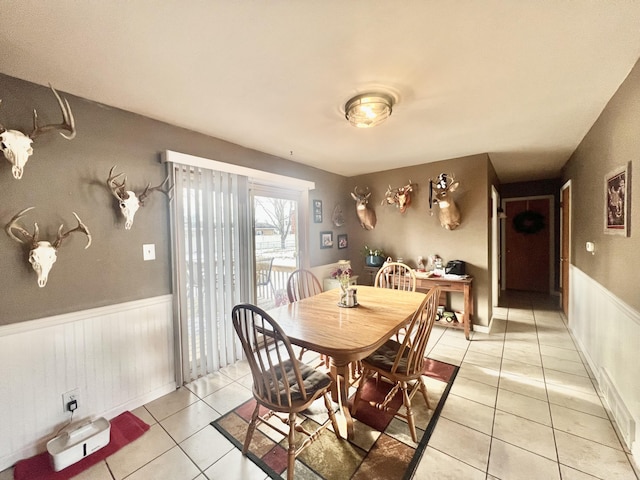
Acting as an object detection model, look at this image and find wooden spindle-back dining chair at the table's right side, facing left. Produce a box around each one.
[352,286,440,442]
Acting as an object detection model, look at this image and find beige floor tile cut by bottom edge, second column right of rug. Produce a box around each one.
[488,438,560,480]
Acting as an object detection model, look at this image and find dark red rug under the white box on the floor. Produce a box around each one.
[13,412,149,480]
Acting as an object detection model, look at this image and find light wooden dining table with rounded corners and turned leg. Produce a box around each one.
[268,285,425,438]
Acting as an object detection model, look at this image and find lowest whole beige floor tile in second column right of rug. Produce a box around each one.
[493,410,558,462]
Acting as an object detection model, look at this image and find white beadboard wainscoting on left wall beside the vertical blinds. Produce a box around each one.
[0,295,176,471]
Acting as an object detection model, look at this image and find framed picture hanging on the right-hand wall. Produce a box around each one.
[604,164,631,237]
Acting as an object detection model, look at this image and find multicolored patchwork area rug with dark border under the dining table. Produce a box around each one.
[211,359,458,480]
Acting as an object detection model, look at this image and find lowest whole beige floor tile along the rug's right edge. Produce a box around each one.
[429,418,491,472]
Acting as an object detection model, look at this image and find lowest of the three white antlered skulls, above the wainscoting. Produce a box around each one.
[5,207,91,288]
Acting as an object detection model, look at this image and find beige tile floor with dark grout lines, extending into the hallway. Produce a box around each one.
[0,294,638,480]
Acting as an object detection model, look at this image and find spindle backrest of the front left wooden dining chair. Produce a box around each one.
[231,303,307,409]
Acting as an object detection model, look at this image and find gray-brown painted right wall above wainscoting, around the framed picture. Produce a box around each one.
[563,57,640,310]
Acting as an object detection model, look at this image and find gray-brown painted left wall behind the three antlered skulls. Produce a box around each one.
[0,74,345,325]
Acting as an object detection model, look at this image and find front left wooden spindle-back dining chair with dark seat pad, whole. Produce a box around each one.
[231,304,341,480]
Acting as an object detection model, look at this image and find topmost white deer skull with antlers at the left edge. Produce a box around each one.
[0,85,76,180]
